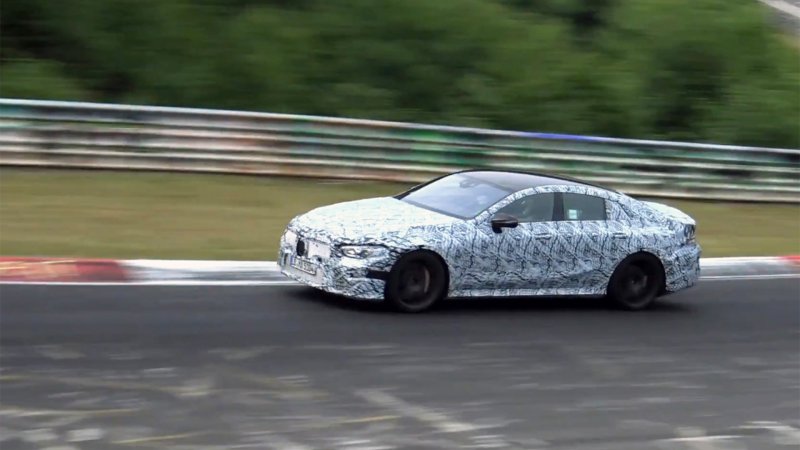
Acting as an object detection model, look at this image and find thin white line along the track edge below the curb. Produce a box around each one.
[0,273,800,287]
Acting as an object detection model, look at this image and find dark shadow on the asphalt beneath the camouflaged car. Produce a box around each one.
[291,288,693,315]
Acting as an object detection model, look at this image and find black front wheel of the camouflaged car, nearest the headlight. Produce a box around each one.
[384,251,448,313]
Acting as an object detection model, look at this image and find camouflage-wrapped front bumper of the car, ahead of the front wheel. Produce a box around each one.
[278,232,391,300]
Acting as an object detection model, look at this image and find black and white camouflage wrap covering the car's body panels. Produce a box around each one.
[278,184,700,300]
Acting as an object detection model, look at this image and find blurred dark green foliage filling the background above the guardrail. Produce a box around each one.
[0,0,800,147]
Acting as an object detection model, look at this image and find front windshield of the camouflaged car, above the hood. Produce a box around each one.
[400,173,513,219]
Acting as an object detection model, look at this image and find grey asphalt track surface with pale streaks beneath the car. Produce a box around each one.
[0,279,800,450]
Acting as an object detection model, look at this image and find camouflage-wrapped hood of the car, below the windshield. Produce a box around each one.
[289,197,459,243]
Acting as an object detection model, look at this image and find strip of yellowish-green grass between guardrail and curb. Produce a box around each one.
[0,168,800,260]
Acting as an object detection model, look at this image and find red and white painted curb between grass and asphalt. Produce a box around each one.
[0,255,800,286]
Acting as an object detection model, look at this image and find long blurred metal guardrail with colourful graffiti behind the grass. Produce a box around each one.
[0,99,800,203]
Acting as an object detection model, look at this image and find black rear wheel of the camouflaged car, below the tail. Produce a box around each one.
[608,253,664,311]
